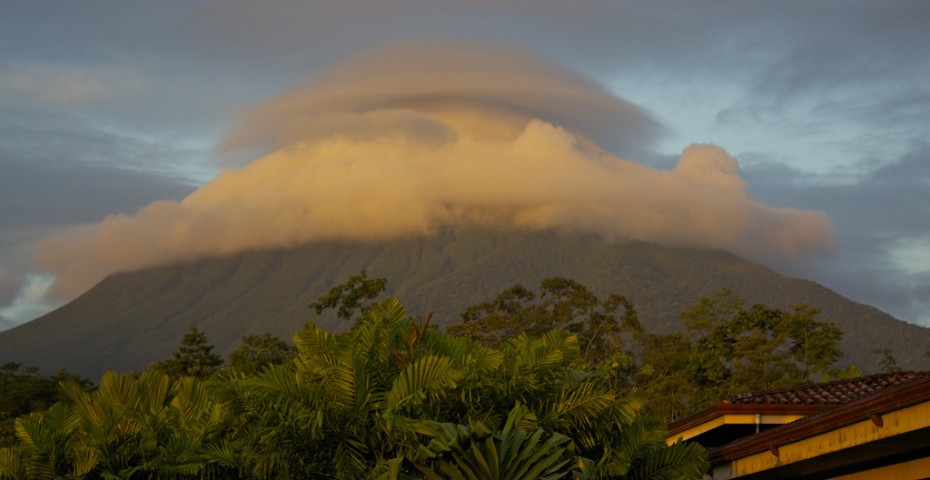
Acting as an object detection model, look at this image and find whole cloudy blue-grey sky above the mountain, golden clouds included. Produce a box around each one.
[0,0,930,328]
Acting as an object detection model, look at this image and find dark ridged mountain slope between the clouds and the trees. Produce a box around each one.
[0,230,930,378]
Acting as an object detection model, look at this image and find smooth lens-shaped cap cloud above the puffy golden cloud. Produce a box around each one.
[222,41,660,158]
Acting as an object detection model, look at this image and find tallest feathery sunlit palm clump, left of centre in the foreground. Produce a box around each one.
[211,298,465,478]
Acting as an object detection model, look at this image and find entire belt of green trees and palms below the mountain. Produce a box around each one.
[0,272,856,479]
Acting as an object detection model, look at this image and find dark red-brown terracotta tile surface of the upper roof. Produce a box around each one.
[723,372,930,405]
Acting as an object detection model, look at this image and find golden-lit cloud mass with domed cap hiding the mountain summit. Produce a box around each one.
[38,42,833,296]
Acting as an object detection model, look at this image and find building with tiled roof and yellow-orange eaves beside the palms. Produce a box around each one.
[667,372,930,480]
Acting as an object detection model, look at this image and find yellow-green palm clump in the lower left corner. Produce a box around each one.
[0,370,235,479]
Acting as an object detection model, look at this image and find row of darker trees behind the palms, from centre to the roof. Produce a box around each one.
[448,278,842,421]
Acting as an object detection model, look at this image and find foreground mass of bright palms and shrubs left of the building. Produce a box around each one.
[0,284,707,479]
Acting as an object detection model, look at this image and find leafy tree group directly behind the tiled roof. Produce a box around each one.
[635,290,842,421]
